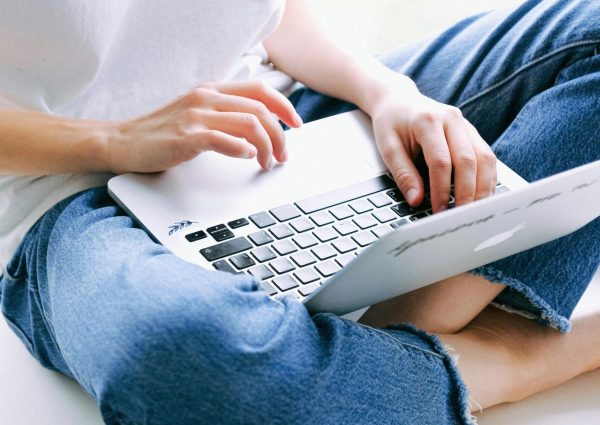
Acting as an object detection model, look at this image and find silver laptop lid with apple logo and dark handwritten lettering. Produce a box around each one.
[305,161,600,314]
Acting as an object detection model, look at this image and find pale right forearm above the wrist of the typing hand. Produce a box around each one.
[264,0,415,113]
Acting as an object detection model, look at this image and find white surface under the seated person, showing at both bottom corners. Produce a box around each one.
[0,275,600,425]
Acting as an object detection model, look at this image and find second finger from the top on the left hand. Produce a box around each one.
[213,94,287,162]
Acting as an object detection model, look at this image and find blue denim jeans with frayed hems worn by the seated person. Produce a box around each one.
[0,0,600,425]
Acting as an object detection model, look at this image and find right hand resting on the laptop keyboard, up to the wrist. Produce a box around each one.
[370,77,496,212]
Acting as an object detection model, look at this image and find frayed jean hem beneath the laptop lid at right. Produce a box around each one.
[471,265,571,333]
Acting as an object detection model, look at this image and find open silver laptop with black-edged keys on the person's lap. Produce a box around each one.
[108,111,600,315]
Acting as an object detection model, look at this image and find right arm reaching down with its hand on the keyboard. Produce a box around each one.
[265,0,496,211]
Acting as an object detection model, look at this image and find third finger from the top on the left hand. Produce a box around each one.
[196,111,273,169]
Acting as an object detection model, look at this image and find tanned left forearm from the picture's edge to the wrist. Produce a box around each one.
[0,109,113,175]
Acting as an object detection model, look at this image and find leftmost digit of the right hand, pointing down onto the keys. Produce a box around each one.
[376,129,425,206]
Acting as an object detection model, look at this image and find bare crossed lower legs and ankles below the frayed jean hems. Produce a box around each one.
[360,273,600,410]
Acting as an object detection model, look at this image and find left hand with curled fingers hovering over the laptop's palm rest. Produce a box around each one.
[107,82,302,174]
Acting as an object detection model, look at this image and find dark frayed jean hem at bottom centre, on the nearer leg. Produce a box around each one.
[383,323,477,425]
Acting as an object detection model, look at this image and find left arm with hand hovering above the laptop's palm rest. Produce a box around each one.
[0,82,301,175]
